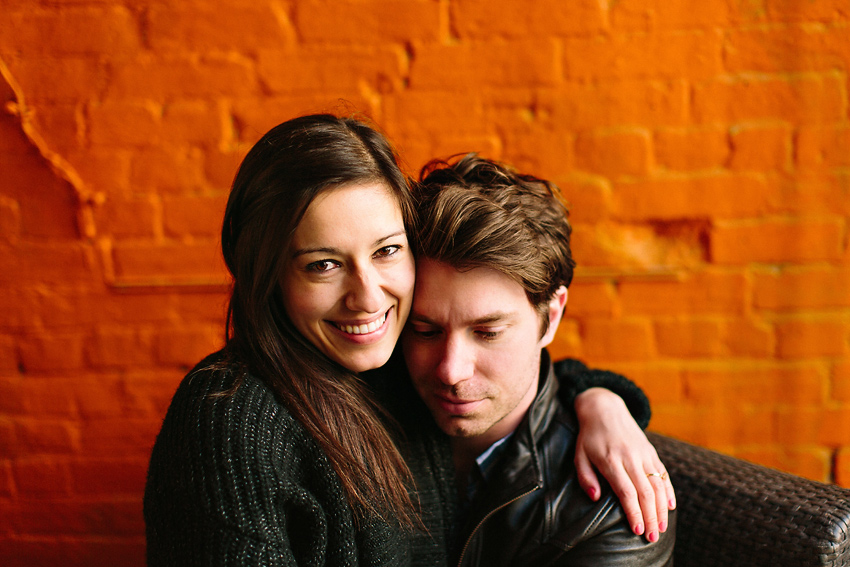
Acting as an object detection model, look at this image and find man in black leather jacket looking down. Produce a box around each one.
[403,154,675,567]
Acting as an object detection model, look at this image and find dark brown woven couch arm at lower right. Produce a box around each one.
[649,433,850,567]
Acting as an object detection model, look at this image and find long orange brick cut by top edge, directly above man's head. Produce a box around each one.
[449,0,606,39]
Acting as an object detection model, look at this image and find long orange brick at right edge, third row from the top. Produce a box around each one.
[693,75,846,124]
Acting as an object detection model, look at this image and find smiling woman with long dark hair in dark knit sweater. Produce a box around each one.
[145,115,672,565]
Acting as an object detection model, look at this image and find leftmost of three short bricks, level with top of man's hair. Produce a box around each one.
[575,130,652,177]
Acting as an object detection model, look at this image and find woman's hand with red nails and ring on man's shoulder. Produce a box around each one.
[575,388,676,542]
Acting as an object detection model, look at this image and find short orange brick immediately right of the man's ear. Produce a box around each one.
[581,319,654,361]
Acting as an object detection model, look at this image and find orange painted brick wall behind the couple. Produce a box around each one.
[0,0,850,567]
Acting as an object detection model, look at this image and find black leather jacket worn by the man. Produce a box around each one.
[453,351,676,567]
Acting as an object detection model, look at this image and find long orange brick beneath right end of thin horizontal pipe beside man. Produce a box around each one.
[619,272,748,316]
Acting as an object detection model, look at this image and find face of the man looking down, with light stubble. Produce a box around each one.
[402,259,566,450]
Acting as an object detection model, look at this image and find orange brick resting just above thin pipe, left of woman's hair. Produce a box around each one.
[112,242,225,284]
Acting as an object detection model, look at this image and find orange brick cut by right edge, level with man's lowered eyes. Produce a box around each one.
[776,317,850,358]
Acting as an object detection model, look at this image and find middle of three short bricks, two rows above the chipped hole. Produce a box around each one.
[654,127,730,171]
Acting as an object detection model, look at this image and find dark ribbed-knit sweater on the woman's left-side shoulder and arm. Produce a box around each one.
[144,355,410,567]
